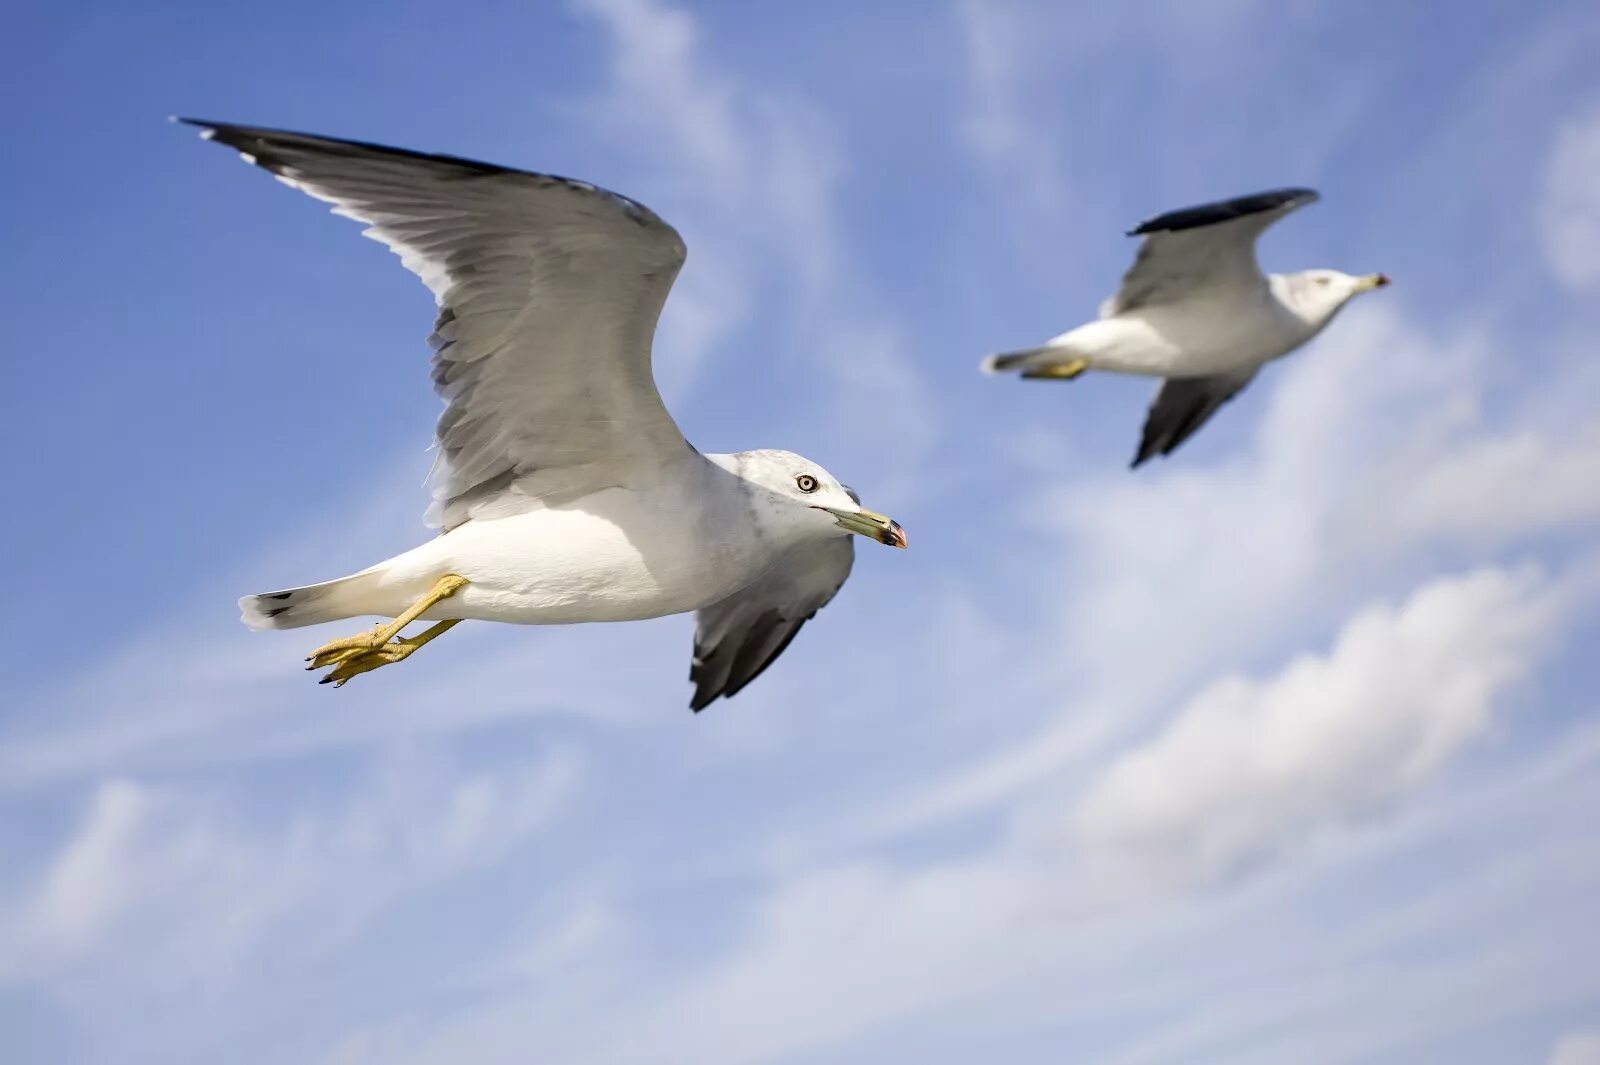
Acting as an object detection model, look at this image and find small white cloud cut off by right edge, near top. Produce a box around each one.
[1539,107,1600,291]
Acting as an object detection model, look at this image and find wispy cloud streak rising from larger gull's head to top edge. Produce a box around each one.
[574,0,938,476]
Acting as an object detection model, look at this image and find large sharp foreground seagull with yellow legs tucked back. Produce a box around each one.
[182,118,906,710]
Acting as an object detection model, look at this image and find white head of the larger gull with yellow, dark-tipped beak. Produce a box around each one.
[730,451,906,547]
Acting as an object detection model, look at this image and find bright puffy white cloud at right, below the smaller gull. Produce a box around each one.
[1072,569,1563,883]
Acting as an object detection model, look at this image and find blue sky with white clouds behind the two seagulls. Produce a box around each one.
[0,0,1600,1065]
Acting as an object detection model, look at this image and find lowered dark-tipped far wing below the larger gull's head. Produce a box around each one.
[690,536,856,713]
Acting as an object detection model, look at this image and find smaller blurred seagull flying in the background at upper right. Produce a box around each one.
[982,189,1389,467]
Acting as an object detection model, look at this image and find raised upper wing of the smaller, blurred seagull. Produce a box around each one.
[1101,189,1318,318]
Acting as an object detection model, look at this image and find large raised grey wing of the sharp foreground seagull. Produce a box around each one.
[184,118,690,529]
